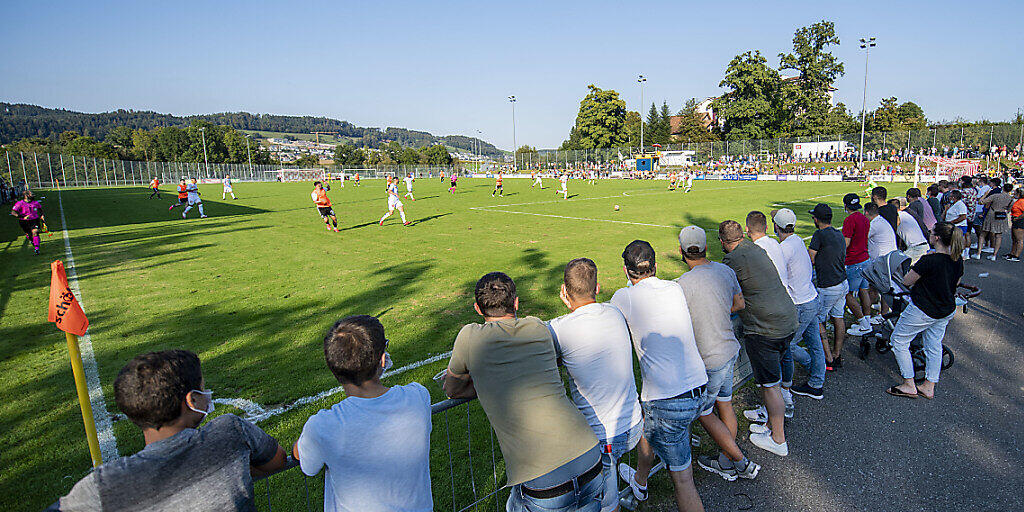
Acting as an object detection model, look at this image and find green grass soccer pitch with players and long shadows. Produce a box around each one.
[0,178,897,510]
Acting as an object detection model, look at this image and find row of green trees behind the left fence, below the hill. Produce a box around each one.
[4,121,271,164]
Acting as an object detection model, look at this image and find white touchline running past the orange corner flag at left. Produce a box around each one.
[57,191,120,462]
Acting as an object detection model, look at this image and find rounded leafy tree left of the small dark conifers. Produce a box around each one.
[562,84,629,150]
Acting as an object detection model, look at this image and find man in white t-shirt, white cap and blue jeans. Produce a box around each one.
[772,208,827,399]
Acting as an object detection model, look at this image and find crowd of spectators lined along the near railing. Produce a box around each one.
[50,177,1024,512]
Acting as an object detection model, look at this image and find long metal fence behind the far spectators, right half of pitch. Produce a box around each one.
[515,124,1024,169]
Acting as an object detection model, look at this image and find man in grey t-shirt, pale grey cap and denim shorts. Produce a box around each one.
[676,225,761,481]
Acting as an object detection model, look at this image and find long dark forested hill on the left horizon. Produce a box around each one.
[0,102,501,156]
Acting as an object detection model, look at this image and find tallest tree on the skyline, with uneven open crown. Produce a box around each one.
[778,20,845,135]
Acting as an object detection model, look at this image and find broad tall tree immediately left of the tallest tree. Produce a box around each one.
[712,50,782,140]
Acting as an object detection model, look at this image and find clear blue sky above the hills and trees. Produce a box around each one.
[0,1,1024,148]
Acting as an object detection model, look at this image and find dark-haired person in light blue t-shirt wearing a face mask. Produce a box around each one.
[292,314,433,512]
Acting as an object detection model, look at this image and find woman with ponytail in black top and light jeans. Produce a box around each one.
[886,222,967,399]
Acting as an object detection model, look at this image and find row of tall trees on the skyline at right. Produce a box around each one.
[561,22,942,150]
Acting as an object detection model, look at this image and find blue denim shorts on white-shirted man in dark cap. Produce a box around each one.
[640,395,705,471]
